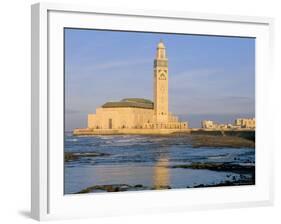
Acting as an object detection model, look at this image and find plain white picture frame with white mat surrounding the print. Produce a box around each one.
[31,3,274,220]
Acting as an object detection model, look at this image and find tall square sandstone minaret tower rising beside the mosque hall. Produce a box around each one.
[154,41,168,123]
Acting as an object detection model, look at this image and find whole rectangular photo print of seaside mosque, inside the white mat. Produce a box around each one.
[64,28,256,194]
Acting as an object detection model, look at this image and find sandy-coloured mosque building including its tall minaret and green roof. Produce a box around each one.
[74,41,188,134]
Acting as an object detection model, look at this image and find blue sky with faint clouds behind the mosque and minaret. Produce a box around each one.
[65,29,255,130]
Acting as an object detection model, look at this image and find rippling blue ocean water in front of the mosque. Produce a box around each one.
[64,133,255,194]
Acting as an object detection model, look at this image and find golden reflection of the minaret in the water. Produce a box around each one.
[153,156,170,189]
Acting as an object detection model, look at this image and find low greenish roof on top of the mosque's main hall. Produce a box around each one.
[102,98,154,109]
